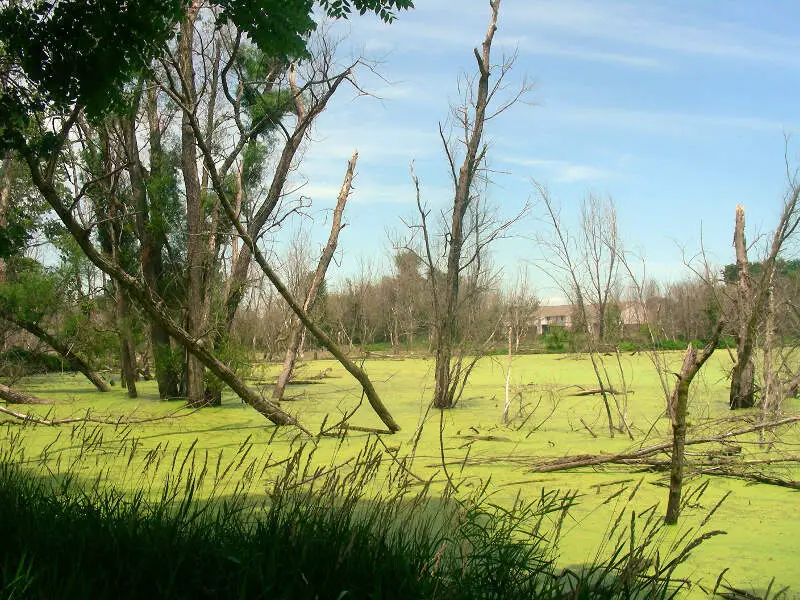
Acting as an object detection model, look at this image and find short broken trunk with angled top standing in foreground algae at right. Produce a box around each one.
[665,321,723,525]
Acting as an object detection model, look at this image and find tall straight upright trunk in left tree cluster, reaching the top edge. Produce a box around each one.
[178,6,206,406]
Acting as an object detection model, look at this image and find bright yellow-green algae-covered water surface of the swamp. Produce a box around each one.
[6,353,800,597]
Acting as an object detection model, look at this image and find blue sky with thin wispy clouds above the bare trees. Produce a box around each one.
[280,0,800,297]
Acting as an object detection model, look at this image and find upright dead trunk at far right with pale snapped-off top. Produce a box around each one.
[729,205,757,409]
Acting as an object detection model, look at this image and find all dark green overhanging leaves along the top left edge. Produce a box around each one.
[0,0,413,151]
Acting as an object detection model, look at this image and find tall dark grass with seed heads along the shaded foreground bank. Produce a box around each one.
[0,424,780,600]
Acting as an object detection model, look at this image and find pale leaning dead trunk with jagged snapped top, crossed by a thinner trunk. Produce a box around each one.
[272,152,358,402]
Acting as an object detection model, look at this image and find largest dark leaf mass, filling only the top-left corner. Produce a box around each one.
[0,0,186,126]
